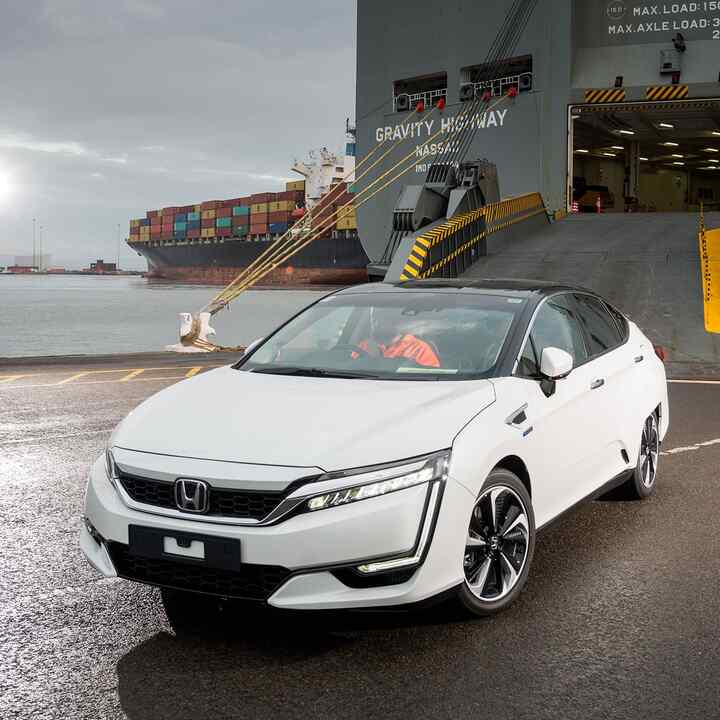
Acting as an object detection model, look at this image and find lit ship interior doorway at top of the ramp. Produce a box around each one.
[568,99,720,212]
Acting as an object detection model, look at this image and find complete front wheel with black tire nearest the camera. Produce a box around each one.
[458,468,535,616]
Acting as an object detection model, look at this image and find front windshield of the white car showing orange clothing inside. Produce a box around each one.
[236,291,525,380]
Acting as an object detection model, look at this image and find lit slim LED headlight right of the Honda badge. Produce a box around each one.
[306,450,450,511]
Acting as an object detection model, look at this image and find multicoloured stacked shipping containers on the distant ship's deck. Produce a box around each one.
[129,180,305,242]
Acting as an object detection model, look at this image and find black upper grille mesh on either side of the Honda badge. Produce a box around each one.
[118,473,284,520]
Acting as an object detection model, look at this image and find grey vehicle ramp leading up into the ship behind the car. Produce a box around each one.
[462,212,720,376]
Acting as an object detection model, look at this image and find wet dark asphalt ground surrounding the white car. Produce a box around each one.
[0,356,720,720]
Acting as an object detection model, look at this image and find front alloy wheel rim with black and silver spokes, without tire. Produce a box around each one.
[463,485,530,602]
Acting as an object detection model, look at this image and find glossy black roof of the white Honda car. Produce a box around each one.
[338,278,596,298]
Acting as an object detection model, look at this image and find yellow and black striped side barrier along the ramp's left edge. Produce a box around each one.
[400,193,545,280]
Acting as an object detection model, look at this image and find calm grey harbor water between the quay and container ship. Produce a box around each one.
[0,275,328,357]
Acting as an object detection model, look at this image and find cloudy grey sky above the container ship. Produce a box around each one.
[0,0,355,269]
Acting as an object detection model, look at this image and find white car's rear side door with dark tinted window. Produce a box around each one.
[573,293,644,489]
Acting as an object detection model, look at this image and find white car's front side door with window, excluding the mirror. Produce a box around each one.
[515,294,598,526]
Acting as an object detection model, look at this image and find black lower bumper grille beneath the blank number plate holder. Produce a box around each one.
[108,542,290,600]
